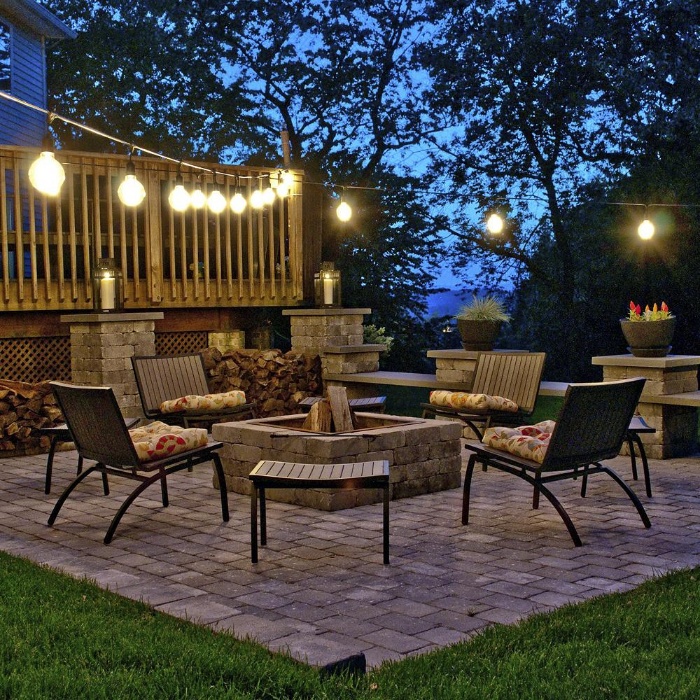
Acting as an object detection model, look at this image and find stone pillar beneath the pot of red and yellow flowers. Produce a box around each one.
[592,355,700,459]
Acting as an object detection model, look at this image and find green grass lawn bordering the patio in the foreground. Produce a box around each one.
[0,553,700,700]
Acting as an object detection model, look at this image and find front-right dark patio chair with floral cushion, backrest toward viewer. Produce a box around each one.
[462,378,651,547]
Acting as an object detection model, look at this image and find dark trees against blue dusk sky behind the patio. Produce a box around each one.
[45,0,700,380]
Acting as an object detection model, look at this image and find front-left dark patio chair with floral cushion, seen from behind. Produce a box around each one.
[49,382,229,544]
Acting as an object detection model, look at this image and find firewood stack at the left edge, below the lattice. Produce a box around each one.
[0,379,63,457]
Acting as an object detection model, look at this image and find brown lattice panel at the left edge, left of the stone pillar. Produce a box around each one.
[0,336,71,384]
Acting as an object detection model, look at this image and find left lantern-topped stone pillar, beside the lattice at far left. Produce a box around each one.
[61,311,163,418]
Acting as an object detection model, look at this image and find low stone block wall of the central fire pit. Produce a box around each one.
[213,413,462,511]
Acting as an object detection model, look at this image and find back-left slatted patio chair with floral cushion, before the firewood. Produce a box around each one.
[131,353,253,430]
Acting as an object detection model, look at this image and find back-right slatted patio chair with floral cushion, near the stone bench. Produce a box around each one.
[421,351,546,439]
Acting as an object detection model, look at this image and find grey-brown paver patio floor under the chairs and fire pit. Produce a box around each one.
[0,442,700,666]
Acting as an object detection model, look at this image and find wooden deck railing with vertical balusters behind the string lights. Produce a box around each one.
[0,146,304,311]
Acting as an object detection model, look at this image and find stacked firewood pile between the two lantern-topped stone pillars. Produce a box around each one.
[202,348,321,418]
